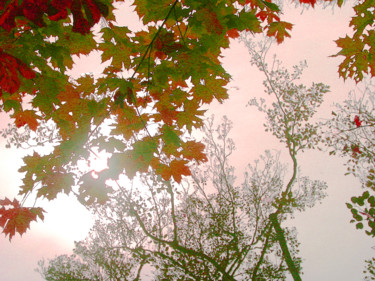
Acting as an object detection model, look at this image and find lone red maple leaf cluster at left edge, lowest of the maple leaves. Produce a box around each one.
[0,198,44,240]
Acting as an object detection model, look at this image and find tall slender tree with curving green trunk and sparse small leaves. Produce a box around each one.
[243,37,329,281]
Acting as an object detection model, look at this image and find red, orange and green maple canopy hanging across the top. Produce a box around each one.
[0,0,375,239]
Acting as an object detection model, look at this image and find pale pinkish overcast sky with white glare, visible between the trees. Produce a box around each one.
[0,1,375,281]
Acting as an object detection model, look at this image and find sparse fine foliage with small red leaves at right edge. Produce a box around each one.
[326,80,375,178]
